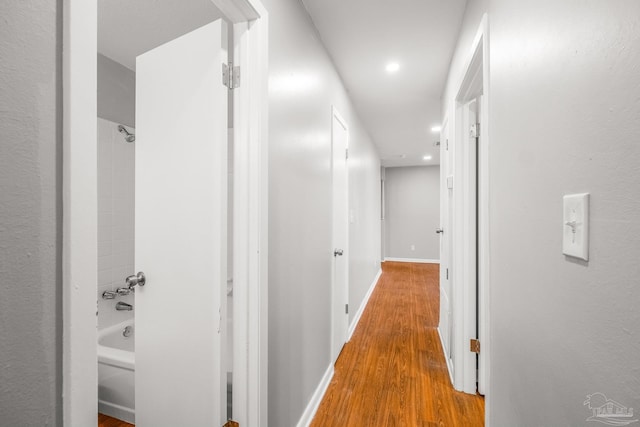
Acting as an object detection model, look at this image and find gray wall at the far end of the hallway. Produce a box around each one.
[385,166,440,260]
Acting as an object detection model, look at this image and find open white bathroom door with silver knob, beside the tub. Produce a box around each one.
[135,20,227,427]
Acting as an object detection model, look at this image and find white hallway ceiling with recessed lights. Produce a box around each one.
[302,0,466,166]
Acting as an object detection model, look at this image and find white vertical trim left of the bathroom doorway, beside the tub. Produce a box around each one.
[62,0,98,426]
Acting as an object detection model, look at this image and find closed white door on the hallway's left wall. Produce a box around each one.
[331,109,349,362]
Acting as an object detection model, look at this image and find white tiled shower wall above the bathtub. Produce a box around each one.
[98,118,135,329]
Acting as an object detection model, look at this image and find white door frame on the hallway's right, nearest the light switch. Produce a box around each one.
[450,14,491,399]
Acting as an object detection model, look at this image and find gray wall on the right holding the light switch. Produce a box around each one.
[447,0,640,426]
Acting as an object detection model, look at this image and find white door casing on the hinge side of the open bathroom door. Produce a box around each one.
[219,0,268,426]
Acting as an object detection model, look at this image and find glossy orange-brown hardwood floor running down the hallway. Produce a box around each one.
[311,262,484,427]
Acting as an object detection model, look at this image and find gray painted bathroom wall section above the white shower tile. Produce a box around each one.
[98,54,136,127]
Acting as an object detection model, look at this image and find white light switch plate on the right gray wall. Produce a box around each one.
[562,193,589,261]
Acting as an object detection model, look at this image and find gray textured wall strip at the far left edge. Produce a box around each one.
[0,0,62,426]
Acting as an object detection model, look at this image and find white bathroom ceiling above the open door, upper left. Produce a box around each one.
[98,0,222,70]
